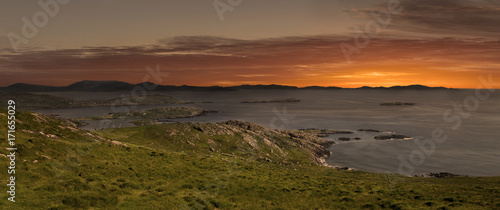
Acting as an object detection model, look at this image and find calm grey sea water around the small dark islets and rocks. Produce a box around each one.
[36,90,500,176]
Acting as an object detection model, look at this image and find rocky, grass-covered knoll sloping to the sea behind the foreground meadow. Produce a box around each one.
[96,121,329,165]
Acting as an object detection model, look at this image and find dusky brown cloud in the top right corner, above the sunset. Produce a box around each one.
[345,0,500,38]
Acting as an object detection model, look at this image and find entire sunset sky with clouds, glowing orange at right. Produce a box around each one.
[0,0,500,88]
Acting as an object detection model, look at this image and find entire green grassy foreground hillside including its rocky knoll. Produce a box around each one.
[0,110,500,209]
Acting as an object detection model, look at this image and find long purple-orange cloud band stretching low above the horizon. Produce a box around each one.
[0,36,500,85]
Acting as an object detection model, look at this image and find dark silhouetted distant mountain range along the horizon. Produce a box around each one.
[0,80,451,92]
